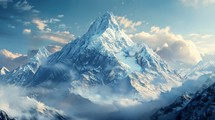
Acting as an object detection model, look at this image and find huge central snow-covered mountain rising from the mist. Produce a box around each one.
[24,13,181,100]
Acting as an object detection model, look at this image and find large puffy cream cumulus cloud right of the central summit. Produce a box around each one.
[130,26,201,65]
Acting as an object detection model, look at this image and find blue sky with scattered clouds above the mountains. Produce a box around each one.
[0,0,215,57]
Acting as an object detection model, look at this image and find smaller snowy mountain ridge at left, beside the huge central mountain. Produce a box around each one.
[0,47,49,85]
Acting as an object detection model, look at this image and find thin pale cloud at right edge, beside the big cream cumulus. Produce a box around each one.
[187,33,215,54]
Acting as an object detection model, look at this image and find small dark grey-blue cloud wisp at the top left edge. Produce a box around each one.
[15,0,34,11]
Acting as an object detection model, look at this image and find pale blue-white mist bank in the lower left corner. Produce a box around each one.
[0,85,45,118]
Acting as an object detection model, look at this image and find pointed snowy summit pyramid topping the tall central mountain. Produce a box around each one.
[81,12,135,53]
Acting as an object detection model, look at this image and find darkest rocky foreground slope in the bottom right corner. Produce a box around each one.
[177,83,215,120]
